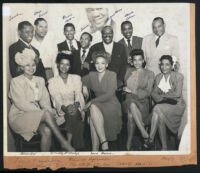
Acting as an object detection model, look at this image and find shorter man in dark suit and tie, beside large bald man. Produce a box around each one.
[72,32,92,77]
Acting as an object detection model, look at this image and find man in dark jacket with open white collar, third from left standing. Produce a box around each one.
[57,23,81,53]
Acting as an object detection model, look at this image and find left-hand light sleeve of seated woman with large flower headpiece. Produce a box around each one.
[9,78,41,111]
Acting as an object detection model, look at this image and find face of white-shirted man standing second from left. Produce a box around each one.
[35,20,48,38]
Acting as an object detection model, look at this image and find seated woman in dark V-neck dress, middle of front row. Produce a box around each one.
[82,51,122,151]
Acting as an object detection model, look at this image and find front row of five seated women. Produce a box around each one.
[8,49,185,151]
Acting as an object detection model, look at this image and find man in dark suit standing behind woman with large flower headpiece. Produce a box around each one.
[9,21,47,81]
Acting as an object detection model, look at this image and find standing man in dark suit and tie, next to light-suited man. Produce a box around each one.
[118,21,143,63]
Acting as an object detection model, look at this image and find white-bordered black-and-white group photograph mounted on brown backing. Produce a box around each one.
[3,3,196,162]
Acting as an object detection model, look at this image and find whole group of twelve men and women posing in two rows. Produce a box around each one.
[8,17,185,151]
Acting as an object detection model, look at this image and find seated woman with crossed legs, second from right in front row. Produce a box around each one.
[123,49,154,150]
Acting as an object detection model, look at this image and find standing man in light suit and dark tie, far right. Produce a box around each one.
[142,17,179,75]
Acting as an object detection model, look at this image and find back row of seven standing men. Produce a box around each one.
[9,17,179,84]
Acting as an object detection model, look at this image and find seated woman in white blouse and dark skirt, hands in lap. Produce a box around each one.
[48,53,85,150]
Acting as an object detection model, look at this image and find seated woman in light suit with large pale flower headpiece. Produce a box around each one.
[8,49,74,151]
